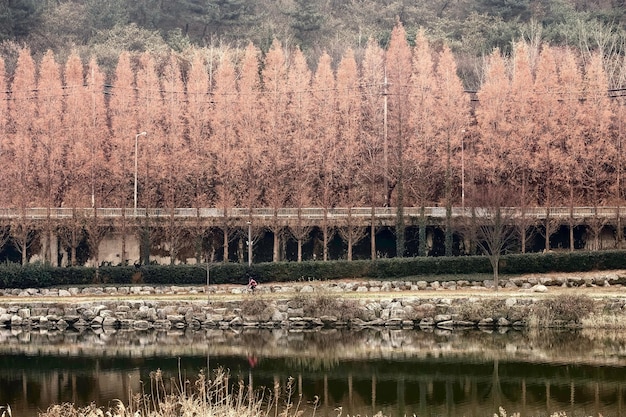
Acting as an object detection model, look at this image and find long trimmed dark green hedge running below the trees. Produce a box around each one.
[0,251,626,288]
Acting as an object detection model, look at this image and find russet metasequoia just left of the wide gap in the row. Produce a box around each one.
[433,45,469,256]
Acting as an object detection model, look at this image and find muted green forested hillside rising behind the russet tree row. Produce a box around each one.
[0,0,626,89]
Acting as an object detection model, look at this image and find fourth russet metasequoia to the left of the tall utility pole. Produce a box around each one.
[283,48,310,262]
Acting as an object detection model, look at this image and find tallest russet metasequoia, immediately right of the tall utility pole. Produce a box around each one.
[384,22,412,257]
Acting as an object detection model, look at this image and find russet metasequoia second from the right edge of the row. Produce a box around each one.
[579,54,617,250]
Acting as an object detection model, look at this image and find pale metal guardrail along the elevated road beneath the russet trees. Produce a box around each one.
[0,206,626,220]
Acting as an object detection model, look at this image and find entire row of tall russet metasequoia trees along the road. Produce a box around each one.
[0,20,624,264]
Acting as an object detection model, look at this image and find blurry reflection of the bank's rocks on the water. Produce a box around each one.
[0,327,626,369]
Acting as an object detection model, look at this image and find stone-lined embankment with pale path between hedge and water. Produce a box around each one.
[0,271,626,331]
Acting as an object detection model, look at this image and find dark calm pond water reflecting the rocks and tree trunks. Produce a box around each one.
[0,329,626,417]
